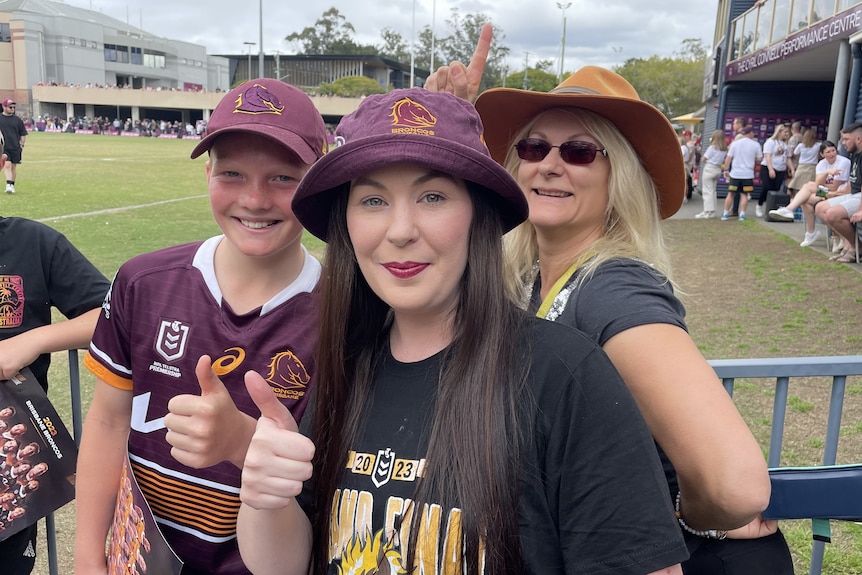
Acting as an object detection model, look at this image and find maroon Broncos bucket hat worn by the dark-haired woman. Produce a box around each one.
[292,88,527,241]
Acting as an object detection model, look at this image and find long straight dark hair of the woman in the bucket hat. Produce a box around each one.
[311,182,529,575]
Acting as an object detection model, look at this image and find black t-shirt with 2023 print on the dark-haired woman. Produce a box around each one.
[300,318,687,575]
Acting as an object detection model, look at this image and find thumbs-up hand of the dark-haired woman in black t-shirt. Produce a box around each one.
[239,371,314,509]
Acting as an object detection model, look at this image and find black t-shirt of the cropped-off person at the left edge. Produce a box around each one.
[0,217,110,389]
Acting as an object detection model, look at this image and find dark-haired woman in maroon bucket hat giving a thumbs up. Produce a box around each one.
[238,88,687,575]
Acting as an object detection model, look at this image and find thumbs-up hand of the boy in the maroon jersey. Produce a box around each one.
[165,355,254,469]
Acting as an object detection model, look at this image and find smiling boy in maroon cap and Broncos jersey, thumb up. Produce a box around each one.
[75,79,326,575]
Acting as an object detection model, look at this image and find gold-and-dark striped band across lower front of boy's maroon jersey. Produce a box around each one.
[132,462,240,537]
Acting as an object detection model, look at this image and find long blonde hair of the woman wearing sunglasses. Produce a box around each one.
[504,108,676,287]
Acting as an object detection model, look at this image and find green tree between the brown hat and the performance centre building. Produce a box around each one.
[614,38,708,118]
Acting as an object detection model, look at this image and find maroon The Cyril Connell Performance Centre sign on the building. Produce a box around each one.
[724,6,862,80]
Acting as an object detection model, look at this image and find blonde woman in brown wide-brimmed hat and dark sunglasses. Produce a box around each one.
[476,66,792,574]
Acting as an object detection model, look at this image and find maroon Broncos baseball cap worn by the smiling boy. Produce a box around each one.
[192,78,326,164]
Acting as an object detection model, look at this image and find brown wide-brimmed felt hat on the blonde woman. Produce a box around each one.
[476,66,686,218]
